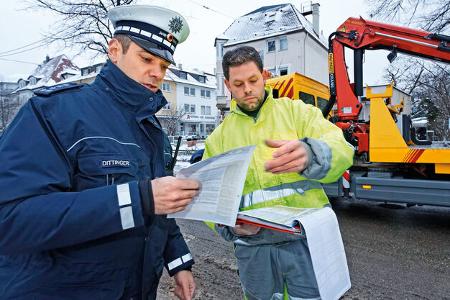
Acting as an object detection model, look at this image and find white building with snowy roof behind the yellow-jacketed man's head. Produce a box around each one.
[215,3,328,110]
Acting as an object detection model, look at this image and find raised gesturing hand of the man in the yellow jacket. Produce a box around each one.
[264,140,308,174]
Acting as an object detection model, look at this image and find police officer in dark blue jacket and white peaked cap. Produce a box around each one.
[0,6,199,299]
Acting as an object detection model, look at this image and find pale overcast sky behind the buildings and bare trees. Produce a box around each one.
[0,0,388,84]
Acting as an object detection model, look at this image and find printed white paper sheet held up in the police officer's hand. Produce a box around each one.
[167,146,255,227]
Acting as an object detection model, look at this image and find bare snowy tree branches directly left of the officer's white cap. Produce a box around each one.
[28,0,136,55]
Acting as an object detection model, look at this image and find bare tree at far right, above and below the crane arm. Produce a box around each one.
[366,0,450,139]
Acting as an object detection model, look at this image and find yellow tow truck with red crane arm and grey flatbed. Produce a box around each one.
[322,18,450,206]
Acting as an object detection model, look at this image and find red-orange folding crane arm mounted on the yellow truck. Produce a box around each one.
[323,18,450,121]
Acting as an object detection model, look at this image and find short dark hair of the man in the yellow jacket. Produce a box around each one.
[222,46,263,80]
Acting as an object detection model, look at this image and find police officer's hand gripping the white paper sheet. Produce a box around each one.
[151,176,200,215]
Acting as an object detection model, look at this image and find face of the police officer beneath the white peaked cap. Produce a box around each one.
[108,39,170,92]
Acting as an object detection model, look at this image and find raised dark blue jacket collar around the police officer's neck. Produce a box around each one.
[94,60,167,119]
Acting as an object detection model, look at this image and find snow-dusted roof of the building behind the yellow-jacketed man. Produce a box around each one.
[220,3,327,47]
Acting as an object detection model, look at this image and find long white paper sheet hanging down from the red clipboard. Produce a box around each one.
[299,207,351,300]
